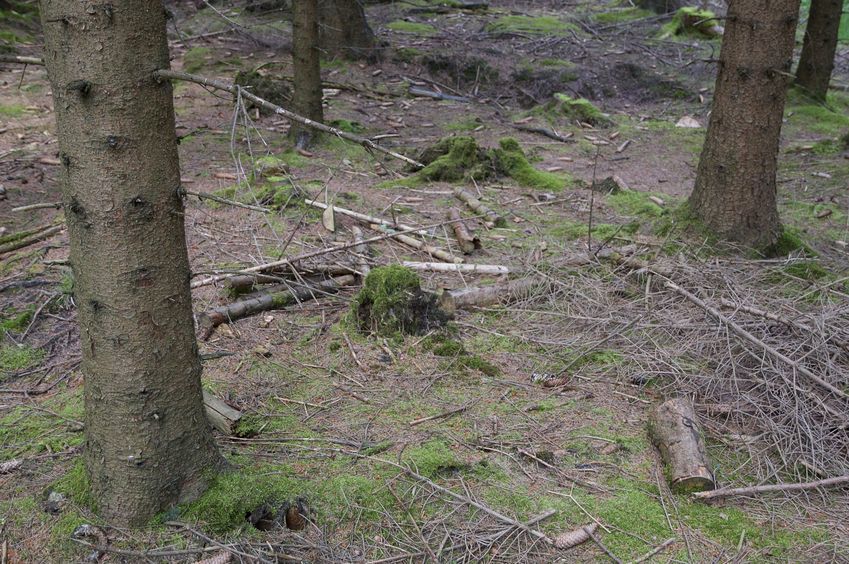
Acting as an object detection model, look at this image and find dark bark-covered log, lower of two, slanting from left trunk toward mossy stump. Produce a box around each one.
[198,274,355,340]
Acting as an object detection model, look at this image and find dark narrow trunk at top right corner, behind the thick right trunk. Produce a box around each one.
[796,0,843,101]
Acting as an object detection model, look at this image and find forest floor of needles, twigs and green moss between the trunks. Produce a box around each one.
[0,0,849,562]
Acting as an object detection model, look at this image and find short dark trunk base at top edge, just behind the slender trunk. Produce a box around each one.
[318,0,376,59]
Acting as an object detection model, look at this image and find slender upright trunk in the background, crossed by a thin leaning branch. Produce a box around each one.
[289,0,324,148]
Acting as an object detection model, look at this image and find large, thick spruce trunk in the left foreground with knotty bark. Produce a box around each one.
[41,0,221,525]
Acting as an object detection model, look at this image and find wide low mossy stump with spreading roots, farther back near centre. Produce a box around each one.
[417,137,566,190]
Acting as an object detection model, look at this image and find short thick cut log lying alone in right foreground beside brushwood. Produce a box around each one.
[649,398,716,493]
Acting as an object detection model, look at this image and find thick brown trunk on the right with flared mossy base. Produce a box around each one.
[690,0,799,249]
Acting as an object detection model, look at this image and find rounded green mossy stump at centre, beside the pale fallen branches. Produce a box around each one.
[351,265,447,337]
